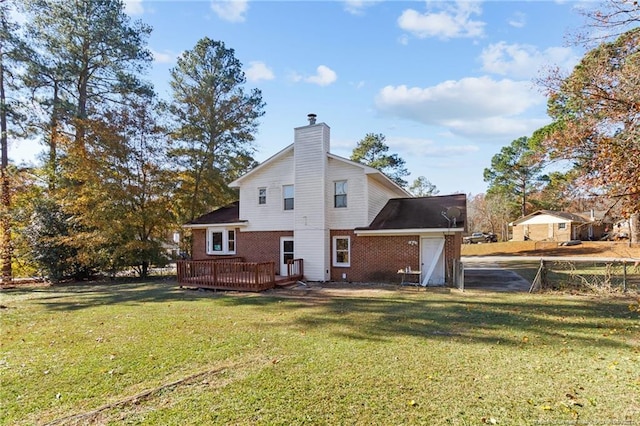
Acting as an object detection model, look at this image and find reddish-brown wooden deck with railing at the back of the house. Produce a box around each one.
[177,257,304,292]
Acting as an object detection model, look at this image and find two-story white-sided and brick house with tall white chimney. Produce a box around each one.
[184,114,466,285]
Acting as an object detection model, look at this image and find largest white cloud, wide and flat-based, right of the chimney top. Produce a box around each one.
[375,77,548,137]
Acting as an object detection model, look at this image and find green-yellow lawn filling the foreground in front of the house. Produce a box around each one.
[0,282,640,425]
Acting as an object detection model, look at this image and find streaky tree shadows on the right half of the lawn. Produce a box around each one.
[224,293,640,350]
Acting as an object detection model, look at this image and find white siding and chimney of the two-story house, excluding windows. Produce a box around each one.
[235,123,406,281]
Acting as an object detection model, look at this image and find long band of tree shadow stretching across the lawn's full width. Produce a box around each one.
[3,281,640,350]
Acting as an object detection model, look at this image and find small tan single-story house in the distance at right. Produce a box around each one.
[509,210,611,242]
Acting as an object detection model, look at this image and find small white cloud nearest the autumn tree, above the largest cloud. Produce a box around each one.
[480,42,579,78]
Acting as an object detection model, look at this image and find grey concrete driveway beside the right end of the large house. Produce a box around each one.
[462,257,531,292]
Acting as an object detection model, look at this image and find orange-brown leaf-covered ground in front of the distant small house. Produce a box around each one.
[462,241,640,260]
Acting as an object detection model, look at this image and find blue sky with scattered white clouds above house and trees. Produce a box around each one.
[14,0,584,194]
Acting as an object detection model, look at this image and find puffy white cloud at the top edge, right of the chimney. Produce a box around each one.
[398,2,485,39]
